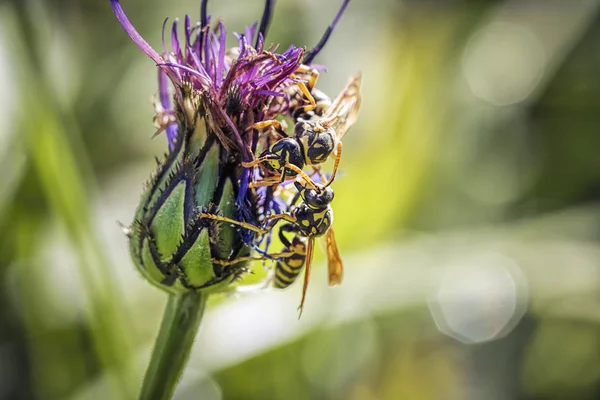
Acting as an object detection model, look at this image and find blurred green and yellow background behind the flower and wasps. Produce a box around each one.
[0,0,600,400]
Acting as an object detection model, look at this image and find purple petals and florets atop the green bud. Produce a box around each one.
[111,0,349,157]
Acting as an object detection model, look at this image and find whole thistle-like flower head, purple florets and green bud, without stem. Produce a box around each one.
[110,0,349,290]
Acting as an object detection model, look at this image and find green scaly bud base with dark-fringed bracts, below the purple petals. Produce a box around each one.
[130,114,250,292]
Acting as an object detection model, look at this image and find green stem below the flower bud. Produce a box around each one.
[140,292,208,400]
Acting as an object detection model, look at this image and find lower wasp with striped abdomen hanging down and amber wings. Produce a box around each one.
[200,181,343,315]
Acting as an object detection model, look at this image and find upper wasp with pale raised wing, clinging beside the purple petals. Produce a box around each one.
[242,71,362,187]
